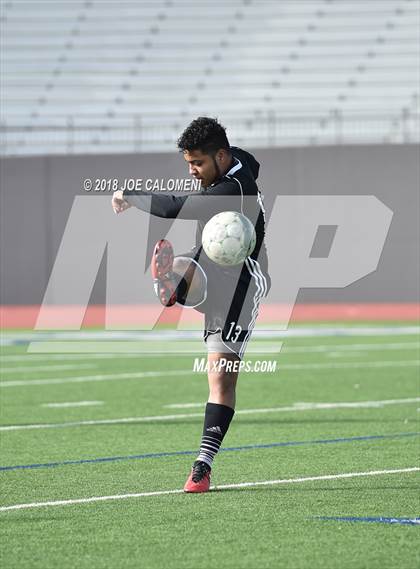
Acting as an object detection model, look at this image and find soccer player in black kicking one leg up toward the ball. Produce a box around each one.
[112,117,270,492]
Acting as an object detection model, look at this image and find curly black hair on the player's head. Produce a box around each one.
[178,117,230,155]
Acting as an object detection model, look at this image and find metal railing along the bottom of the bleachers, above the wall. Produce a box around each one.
[0,109,420,156]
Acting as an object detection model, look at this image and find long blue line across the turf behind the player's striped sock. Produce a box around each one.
[0,432,420,471]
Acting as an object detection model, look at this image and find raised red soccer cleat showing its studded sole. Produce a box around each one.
[151,239,176,306]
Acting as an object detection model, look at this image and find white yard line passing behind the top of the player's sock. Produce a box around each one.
[0,397,420,431]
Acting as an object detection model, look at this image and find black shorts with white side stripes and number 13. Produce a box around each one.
[177,247,271,358]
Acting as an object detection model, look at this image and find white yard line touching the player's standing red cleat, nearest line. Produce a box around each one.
[0,467,420,512]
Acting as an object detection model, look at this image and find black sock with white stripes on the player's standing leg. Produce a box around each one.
[197,403,235,467]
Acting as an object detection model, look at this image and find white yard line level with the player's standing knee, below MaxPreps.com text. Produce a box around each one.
[0,360,420,388]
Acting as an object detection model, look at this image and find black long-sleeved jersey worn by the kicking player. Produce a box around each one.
[124,147,268,274]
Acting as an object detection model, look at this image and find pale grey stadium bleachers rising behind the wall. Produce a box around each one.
[1,0,420,156]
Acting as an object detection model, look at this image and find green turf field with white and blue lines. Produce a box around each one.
[0,325,420,569]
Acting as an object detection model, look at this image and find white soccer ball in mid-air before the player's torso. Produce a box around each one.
[202,211,256,266]
